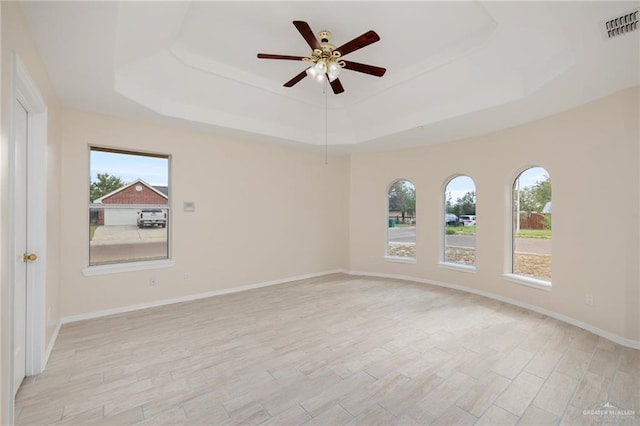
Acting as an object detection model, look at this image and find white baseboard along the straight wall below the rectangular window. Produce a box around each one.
[60,269,346,324]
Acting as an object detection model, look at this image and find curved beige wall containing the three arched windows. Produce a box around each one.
[350,88,640,342]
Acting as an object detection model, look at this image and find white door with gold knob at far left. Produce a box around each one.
[13,100,29,396]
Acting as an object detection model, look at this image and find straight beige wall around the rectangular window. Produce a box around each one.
[61,110,349,317]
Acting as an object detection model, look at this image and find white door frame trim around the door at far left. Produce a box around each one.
[9,53,48,410]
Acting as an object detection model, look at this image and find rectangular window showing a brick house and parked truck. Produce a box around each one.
[88,147,170,266]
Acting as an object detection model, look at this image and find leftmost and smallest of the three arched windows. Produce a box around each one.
[386,180,416,259]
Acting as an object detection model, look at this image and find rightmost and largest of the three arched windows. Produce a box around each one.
[511,167,551,283]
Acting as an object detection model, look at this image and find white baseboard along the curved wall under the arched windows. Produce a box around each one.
[347,271,640,350]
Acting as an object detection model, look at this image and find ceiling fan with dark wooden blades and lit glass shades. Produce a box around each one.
[258,21,387,95]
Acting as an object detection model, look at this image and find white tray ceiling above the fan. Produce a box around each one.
[21,1,640,153]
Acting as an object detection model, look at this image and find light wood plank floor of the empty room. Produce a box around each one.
[16,274,640,425]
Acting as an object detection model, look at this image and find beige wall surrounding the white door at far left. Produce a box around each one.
[0,1,60,424]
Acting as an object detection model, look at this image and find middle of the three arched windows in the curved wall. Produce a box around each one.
[443,176,476,266]
